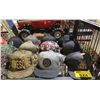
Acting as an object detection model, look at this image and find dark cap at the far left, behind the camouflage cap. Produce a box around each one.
[8,36,23,48]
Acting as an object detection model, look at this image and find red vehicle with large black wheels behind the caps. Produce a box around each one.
[17,20,65,40]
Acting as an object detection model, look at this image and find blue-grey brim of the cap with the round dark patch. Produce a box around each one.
[34,65,60,79]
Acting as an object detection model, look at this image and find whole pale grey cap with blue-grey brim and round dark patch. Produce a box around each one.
[34,51,65,78]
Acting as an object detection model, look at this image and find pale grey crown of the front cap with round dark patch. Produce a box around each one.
[39,51,65,69]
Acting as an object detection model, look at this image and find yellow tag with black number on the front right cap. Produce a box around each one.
[74,71,92,78]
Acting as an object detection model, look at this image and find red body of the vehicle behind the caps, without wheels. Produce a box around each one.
[17,20,64,30]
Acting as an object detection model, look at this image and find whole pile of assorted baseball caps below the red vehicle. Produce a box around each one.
[0,34,91,79]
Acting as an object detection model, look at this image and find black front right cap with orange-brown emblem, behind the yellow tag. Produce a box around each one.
[65,52,92,79]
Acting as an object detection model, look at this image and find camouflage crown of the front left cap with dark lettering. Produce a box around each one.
[8,50,38,71]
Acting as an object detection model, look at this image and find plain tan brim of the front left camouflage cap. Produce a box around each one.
[7,66,34,79]
